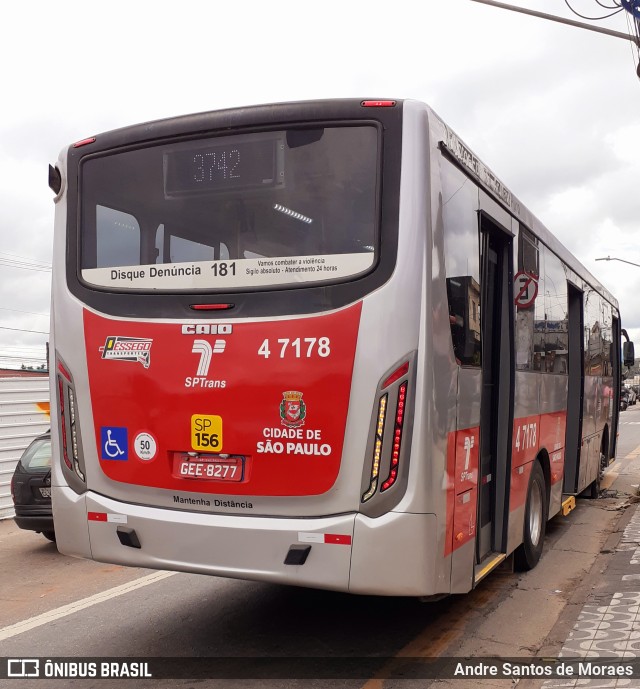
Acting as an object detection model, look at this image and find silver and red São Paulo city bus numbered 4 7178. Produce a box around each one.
[49,99,633,598]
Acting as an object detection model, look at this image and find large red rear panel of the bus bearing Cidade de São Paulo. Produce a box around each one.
[84,302,362,502]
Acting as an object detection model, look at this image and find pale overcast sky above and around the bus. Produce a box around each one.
[0,0,640,368]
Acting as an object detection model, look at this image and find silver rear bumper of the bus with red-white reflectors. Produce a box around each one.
[53,488,435,595]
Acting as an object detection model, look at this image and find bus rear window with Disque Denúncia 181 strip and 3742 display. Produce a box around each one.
[80,126,378,291]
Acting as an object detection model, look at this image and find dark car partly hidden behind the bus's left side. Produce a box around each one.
[11,431,56,541]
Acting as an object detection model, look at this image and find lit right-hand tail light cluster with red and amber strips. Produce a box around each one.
[362,361,409,502]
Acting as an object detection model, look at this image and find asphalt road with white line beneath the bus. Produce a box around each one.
[0,404,640,689]
